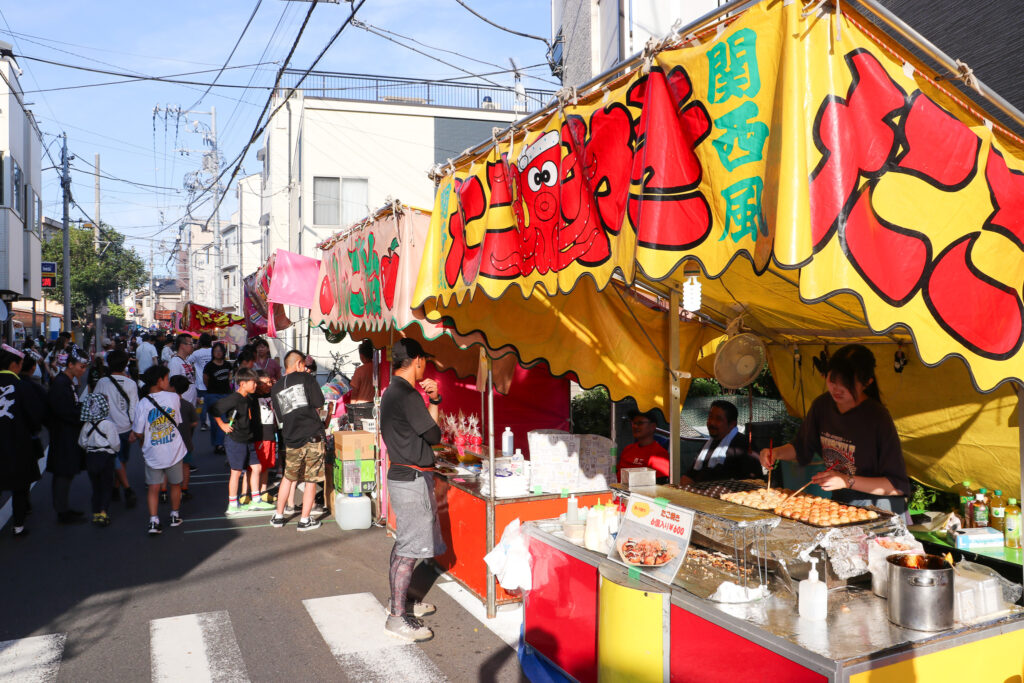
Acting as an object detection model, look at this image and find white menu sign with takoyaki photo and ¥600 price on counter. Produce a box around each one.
[608,494,693,584]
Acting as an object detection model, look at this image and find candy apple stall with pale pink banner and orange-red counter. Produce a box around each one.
[311,202,611,614]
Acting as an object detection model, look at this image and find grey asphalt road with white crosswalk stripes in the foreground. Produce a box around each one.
[0,423,525,682]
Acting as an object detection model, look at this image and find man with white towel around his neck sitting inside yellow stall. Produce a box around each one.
[680,399,761,484]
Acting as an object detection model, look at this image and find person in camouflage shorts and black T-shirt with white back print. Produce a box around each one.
[270,349,326,531]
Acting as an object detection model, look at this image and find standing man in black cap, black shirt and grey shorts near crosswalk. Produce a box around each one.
[381,339,445,642]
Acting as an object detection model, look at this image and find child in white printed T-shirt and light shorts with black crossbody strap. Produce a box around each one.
[132,366,186,536]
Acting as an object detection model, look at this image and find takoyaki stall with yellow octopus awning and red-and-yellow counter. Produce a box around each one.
[413,0,1024,680]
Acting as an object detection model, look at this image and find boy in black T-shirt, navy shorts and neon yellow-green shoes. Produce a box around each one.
[212,368,273,515]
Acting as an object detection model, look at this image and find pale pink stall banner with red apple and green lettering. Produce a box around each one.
[311,206,441,339]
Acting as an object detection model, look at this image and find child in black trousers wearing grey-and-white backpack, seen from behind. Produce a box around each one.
[78,393,121,526]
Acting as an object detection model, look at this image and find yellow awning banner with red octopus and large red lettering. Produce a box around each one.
[412,2,1024,390]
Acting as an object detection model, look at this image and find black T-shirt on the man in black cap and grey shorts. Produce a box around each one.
[381,375,441,481]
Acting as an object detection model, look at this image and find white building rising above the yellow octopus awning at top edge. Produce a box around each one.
[551,0,725,86]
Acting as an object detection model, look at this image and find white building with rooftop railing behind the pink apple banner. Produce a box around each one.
[254,73,552,372]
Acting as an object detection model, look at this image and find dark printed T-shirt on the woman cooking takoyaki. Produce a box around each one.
[793,393,910,509]
